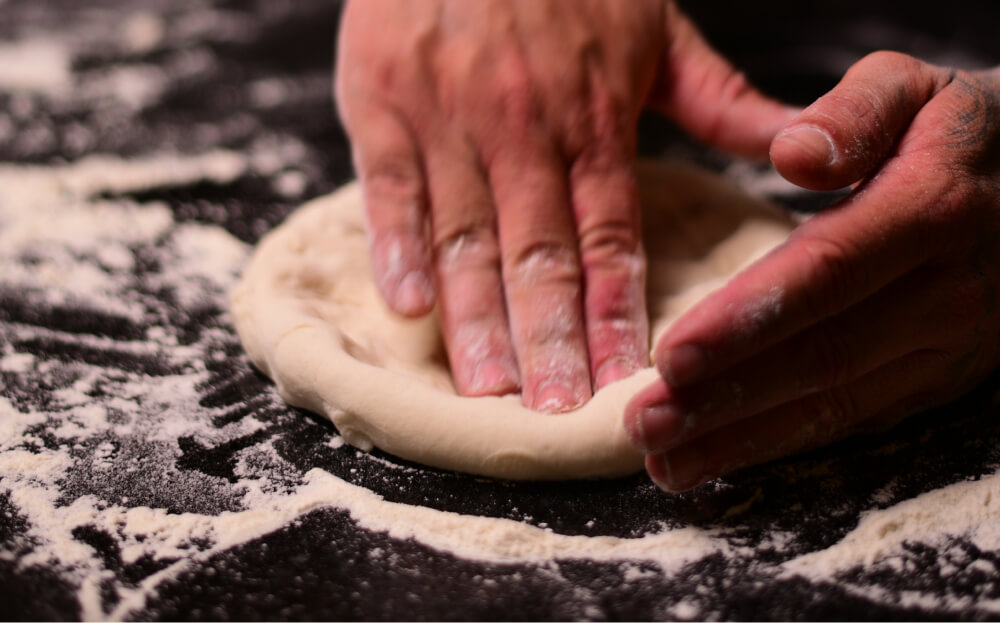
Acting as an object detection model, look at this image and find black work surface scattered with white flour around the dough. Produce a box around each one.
[0,0,1000,619]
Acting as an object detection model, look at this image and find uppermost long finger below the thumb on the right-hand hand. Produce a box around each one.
[654,155,951,387]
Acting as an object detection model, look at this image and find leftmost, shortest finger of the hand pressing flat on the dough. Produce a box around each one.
[350,104,434,316]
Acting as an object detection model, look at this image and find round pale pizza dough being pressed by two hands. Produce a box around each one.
[232,163,792,480]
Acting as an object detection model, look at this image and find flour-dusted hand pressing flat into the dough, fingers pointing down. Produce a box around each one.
[336,0,793,411]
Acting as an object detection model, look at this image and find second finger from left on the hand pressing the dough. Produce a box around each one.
[427,141,519,396]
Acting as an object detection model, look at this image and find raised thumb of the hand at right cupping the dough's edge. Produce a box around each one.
[771,52,951,190]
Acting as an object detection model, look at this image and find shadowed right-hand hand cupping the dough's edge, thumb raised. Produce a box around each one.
[625,52,1000,490]
